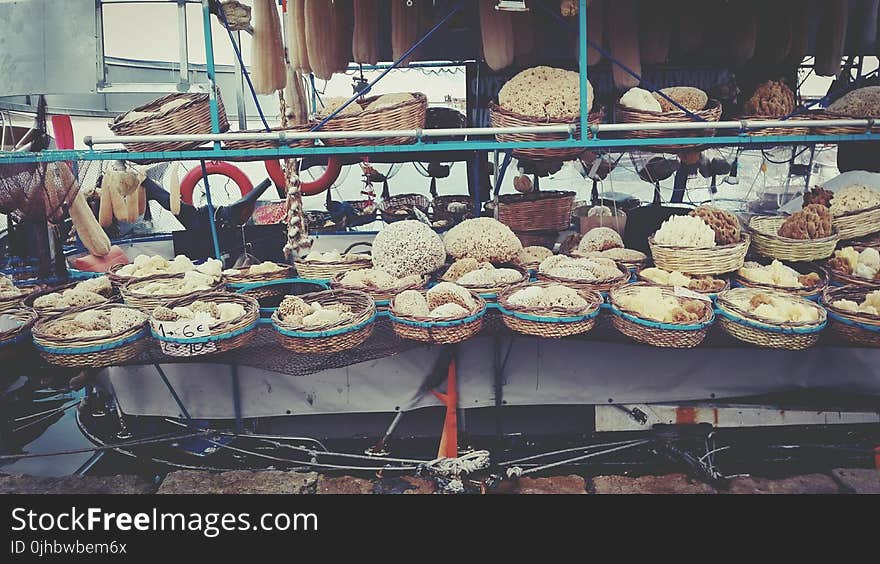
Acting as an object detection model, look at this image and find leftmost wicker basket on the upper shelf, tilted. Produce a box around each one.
[109,90,229,153]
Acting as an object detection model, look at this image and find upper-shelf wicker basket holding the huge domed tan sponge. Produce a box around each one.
[489,102,605,161]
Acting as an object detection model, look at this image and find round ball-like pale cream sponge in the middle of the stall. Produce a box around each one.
[373,220,446,278]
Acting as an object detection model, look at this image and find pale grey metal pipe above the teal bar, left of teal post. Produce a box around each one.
[83,124,574,147]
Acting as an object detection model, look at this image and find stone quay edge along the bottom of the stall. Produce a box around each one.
[0,468,880,494]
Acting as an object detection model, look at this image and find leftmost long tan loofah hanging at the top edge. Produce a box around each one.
[251,0,287,94]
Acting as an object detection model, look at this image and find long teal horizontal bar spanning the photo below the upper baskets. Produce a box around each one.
[6,133,880,165]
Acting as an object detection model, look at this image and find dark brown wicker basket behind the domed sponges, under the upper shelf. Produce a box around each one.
[498,190,575,232]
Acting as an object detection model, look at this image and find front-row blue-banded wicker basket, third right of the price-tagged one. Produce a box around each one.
[498,282,604,339]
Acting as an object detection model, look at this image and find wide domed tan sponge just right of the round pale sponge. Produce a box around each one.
[446,217,522,264]
